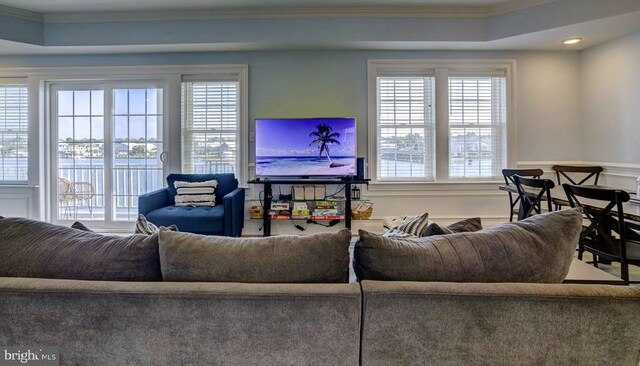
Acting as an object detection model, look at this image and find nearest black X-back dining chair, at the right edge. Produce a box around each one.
[562,183,640,283]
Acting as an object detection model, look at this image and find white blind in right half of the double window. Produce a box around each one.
[449,76,507,178]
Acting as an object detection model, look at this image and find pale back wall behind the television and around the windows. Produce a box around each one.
[0,51,583,234]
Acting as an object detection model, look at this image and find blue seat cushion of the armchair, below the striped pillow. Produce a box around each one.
[146,205,224,233]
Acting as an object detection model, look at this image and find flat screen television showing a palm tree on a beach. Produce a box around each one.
[255,118,356,177]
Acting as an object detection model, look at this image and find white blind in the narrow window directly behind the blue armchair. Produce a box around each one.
[182,81,239,175]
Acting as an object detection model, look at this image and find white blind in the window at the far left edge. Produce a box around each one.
[0,84,29,182]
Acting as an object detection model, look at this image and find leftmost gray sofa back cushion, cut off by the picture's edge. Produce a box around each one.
[0,218,162,281]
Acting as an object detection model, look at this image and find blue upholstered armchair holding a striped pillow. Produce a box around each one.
[138,173,244,236]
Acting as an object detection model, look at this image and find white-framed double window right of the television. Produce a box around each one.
[368,61,513,182]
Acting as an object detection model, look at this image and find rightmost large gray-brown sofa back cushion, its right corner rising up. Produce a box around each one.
[353,209,582,283]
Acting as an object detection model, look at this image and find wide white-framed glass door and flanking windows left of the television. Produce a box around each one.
[0,65,249,227]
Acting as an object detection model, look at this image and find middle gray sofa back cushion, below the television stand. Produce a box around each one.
[160,229,351,283]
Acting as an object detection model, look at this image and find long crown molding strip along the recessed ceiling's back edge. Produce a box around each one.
[44,6,489,23]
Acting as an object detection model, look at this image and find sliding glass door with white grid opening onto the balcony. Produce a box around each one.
[51,83,164,227]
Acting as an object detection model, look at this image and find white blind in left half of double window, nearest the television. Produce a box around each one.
[376,76,435,181]
